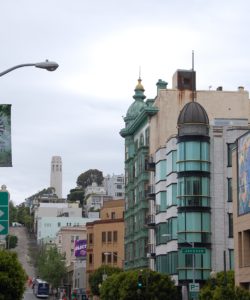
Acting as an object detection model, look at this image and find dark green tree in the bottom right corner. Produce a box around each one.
[199,271,250,300]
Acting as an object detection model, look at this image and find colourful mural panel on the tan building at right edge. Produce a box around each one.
[237,132,250,215]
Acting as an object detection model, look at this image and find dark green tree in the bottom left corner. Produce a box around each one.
[0,250,27,300]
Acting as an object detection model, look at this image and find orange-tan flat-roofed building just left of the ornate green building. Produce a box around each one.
[86,200,124,292]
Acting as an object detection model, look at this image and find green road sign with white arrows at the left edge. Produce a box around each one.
[0,190,9,235]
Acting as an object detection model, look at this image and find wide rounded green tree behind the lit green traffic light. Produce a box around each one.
[98,269,179,300]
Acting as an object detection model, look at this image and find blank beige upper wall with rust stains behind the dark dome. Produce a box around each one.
[149,70,250,154]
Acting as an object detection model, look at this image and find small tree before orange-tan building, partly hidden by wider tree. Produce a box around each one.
[89,266,122,296]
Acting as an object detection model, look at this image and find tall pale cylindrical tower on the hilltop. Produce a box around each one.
[50,156,62,198]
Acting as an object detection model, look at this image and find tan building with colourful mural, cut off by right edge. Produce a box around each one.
[233,131,250,290]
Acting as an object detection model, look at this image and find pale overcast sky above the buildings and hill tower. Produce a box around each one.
[0,0,250,204]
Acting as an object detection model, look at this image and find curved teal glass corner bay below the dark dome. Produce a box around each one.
[176,137,211,281]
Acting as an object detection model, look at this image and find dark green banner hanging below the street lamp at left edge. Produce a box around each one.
[0,104,12,167]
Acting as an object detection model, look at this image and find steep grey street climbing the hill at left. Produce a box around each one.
[9,227,53,300]
